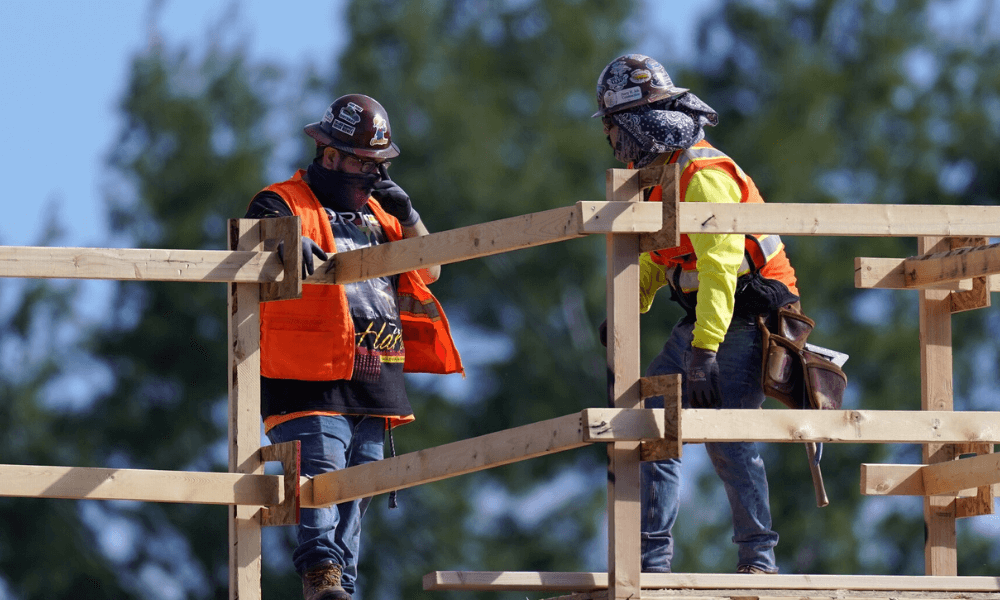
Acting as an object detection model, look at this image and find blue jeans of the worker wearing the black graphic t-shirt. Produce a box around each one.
[267,415,385,594]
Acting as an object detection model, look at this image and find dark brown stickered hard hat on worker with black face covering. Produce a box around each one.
[304,94,399,158]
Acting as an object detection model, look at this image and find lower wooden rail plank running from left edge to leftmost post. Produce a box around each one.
[0,465,284,506]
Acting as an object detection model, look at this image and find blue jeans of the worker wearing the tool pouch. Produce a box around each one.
[642,315,778,573]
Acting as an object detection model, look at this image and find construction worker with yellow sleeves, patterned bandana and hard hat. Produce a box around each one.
[594,54,798,573]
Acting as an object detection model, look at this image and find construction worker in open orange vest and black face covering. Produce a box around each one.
[246,94,463,600]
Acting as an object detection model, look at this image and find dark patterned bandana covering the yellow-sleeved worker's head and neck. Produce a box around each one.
[608,92,719,169]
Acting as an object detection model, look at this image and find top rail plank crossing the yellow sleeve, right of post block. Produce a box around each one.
[677,202,1000,237]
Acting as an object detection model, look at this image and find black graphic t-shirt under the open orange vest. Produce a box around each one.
[246,192,413,418]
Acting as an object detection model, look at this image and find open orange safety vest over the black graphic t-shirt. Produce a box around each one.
[260,169,465,381]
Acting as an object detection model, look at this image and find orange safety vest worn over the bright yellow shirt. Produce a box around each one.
[649,140,799,295]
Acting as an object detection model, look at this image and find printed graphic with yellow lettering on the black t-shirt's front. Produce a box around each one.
[326,208,405,381]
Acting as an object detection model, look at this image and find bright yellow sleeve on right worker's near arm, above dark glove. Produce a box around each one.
[684,169,744,351]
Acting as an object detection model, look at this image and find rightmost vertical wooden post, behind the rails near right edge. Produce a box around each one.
[918,237,958,575]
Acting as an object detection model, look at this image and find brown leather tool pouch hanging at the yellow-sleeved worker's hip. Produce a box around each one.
[757,302,847,410]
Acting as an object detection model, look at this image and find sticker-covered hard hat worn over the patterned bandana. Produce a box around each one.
[593,54,688,117]
